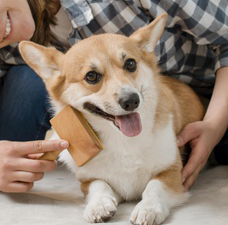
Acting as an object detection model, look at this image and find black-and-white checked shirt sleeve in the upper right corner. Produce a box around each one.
[160,0,228,70]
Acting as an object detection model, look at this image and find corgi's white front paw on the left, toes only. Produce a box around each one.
[84,196,118,223]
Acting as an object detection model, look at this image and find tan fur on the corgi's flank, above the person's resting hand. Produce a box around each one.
[156,76,204,134]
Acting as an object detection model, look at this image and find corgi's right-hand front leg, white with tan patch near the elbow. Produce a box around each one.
[130,165,189,225]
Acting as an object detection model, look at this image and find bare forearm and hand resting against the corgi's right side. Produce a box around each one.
[178,67,228,190]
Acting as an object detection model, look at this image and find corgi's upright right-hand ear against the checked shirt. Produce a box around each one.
[130,13,167,52]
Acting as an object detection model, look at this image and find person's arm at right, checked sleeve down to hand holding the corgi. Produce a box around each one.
[162,0,228,190]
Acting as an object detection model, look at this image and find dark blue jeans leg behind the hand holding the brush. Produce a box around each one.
[0,65,51,141]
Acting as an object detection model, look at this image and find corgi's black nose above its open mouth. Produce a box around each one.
[119,93,140,111]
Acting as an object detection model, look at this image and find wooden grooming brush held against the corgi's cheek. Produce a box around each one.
[40,106,104,166]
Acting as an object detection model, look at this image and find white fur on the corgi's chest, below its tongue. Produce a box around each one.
[60,118,177,200]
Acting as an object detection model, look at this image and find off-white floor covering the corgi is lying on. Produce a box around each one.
[0,163,228,225]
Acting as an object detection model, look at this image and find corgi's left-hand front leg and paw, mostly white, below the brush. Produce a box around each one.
[81,180,122,223]
